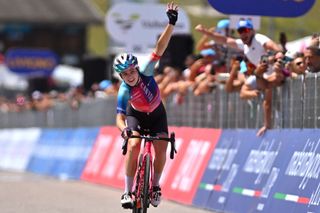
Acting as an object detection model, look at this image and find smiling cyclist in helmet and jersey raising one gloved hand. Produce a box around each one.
[113,2,178,208]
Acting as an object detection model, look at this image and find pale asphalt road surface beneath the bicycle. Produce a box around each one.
[0,171,216,213]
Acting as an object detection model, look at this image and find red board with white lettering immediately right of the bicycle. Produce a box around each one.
[162,127,221,204]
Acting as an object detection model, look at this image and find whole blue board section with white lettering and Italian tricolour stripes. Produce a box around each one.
[193,129,320,213]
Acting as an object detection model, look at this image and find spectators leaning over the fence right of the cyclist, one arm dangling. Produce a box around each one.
[155,20,320,136]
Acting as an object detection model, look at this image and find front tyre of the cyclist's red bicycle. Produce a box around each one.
[142,155,150,213]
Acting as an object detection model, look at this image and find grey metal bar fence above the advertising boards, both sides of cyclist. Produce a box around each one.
[0,73,320,129]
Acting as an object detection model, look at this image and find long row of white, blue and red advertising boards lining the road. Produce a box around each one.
[0,126,320,213]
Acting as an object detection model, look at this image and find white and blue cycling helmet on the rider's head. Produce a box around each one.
[113,53,138,74]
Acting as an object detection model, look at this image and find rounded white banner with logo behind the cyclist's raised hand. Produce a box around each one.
[106,2,190,53]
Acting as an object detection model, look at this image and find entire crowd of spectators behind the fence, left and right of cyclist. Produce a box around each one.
[0,19,320,136]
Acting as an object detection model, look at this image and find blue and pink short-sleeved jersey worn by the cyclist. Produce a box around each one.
[117,53,161,114]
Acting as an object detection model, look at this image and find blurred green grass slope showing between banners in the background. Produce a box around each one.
[87,0,320,56]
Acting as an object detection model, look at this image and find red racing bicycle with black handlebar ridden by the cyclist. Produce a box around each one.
[122,132,177,213]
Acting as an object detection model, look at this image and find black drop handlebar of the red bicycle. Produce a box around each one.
[122,132,177,159]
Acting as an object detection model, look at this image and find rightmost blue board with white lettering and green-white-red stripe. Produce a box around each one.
[264,129,320,213]
